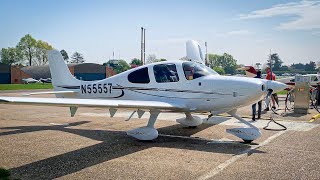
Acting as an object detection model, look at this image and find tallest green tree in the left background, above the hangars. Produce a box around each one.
[17,34,37,66]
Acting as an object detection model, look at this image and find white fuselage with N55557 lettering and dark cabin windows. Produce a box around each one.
[55,61,284,113]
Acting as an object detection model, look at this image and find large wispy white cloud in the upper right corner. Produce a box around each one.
[239,1,320,30]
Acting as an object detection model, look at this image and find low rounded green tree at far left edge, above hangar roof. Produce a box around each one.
[1,47,23,65]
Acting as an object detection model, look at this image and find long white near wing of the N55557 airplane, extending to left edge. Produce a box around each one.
[0,96,187,112]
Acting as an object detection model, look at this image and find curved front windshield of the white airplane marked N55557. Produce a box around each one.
[182,62,218,80]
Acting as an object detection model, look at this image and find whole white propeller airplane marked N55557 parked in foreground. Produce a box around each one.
[0,41,286,143]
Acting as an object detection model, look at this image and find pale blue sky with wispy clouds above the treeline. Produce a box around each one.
[0,0,320,65]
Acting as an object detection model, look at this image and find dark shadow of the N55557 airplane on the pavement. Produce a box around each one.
[0,121,258,179]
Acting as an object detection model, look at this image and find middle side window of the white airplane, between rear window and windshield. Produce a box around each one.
[153,64,179,83]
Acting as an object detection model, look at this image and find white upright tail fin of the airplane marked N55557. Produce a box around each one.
[48,50,81,87]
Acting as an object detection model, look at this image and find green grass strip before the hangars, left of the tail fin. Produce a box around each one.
[0,83,53,91]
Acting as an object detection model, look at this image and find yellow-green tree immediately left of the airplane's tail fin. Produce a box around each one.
[33,40,53,65]
